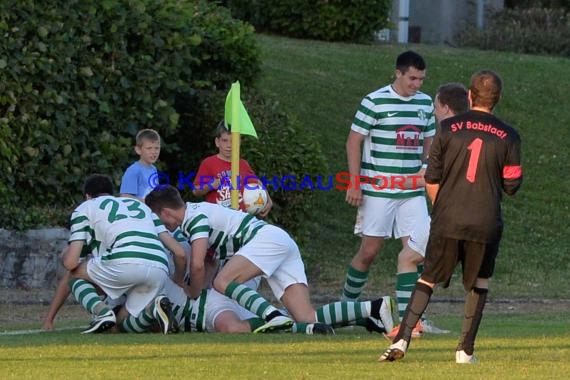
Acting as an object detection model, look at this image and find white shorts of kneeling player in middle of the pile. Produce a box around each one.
[236,225,307,300]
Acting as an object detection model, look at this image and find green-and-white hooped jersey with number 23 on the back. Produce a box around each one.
[69,196,168,270]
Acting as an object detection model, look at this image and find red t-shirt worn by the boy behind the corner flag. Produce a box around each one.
[193,154,259,210]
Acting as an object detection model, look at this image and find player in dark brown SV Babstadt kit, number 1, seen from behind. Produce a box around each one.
[379,70,522,364]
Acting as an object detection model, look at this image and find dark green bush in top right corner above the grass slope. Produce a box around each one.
[455,8,570,57]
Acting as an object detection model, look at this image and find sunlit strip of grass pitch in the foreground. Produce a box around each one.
[0,313,570,380]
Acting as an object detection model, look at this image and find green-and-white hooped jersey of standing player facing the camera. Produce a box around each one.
[351,85,435,198]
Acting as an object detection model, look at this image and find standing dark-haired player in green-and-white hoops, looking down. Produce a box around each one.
[342,51,435,308]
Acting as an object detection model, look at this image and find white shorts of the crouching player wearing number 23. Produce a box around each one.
[87,257,168,317]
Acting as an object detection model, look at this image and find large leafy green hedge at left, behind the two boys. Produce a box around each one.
[0,0,324,238]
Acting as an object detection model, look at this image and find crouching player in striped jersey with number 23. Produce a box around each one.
[62,174,185,333]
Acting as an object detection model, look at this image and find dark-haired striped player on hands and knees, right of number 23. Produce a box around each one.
[145,186,393,332]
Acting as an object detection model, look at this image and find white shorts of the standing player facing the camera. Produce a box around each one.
[354,195,429,239]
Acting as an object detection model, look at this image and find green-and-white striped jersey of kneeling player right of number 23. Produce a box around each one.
[182,202,267,260]
